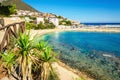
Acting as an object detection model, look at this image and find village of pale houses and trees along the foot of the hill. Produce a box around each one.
[0,10,82,29]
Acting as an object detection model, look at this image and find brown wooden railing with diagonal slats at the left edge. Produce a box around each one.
[0,22,25,52]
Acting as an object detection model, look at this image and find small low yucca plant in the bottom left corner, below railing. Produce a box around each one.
[0,52,16,77]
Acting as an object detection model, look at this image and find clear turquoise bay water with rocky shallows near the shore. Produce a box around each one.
[42,32,120,80]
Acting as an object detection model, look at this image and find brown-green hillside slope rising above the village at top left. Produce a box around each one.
[2,0,38,12]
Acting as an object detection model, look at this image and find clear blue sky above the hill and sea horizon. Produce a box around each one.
[23,0,120,23]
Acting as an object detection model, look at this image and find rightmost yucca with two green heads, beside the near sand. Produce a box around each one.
[37,41,55,80]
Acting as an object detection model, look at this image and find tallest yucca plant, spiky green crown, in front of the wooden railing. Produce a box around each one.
[16,33,34,80]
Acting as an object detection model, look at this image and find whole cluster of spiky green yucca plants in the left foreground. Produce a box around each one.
[0,32,57,80]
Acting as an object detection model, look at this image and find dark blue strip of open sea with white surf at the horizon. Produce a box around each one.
[81,23,120,27]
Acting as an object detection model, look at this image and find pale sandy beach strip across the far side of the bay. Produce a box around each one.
[30,27,120,36]
